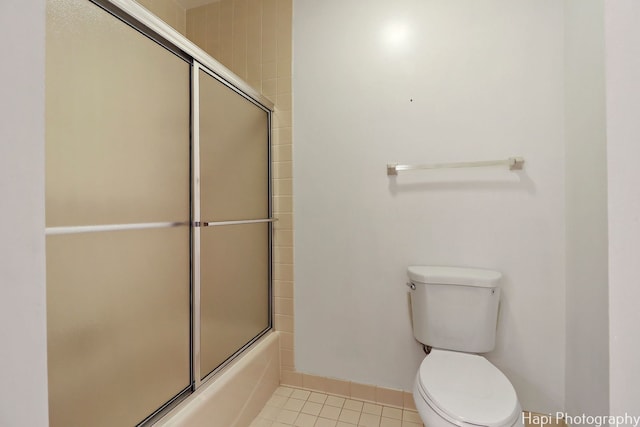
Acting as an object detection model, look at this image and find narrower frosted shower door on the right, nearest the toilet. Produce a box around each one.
[194,70,271,378]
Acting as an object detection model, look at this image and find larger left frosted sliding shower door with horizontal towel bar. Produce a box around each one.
[46,0,191,427]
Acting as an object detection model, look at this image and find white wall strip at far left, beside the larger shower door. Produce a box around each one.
[0,0,48,427]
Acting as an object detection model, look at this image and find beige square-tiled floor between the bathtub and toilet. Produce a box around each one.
[251,386,423,427]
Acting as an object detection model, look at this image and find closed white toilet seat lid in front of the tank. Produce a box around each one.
[416,349,521,427]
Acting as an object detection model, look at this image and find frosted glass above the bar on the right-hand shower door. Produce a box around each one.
[200,71,269,221]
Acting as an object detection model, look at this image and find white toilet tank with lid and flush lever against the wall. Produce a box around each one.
[408,266,502,353]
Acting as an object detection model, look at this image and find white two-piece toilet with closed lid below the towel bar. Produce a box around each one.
[407,266,523,427]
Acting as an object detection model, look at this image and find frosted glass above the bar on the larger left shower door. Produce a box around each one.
[46,0,190,227]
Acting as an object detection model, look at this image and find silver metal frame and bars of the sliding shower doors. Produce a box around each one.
[54,0,276,426]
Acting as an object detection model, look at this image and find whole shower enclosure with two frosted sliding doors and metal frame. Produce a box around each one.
[46,0,272,427]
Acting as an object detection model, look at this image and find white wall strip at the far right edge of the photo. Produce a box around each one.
[605,0,640,416]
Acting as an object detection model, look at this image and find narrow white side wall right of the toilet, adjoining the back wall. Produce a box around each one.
[564,0,609,422]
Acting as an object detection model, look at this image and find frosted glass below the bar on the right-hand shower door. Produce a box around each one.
[200,224,270,377]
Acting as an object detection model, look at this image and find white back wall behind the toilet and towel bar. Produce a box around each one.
[293,0,565,412]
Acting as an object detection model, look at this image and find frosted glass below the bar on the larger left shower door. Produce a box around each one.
[46,226,190,427]
